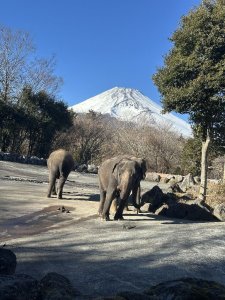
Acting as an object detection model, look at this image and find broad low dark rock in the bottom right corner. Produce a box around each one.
[145,278,225,300]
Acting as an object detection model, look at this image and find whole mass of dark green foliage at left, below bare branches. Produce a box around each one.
[0,88,72,157]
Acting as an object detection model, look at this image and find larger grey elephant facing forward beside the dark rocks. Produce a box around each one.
[98,155,146,220]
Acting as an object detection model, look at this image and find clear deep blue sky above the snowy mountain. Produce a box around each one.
[0,0,201,112]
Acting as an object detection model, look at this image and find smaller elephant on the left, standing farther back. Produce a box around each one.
[47,149,75,199]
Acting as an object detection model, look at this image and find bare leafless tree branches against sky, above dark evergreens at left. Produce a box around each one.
[0,26,62,103]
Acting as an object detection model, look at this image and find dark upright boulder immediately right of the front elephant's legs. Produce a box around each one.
[141,185,165,212]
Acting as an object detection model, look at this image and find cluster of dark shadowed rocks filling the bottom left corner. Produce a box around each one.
[0,248,80,300]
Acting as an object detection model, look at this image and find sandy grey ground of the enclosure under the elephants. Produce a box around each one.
[0,162,225,297]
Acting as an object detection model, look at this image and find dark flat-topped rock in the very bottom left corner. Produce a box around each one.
[0,274,39,300]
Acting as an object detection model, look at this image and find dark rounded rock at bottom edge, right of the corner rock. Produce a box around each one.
[39,272,80,300]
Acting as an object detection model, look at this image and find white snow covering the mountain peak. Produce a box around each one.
[70,87,191,137]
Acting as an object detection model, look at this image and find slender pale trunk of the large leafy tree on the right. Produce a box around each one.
[199,131,210,201]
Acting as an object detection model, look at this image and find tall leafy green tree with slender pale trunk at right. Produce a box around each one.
[153,0,225,200]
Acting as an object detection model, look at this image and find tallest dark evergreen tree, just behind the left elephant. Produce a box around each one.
[17,87,73,157]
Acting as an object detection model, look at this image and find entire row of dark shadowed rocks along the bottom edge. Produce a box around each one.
[0,248,225,300]
